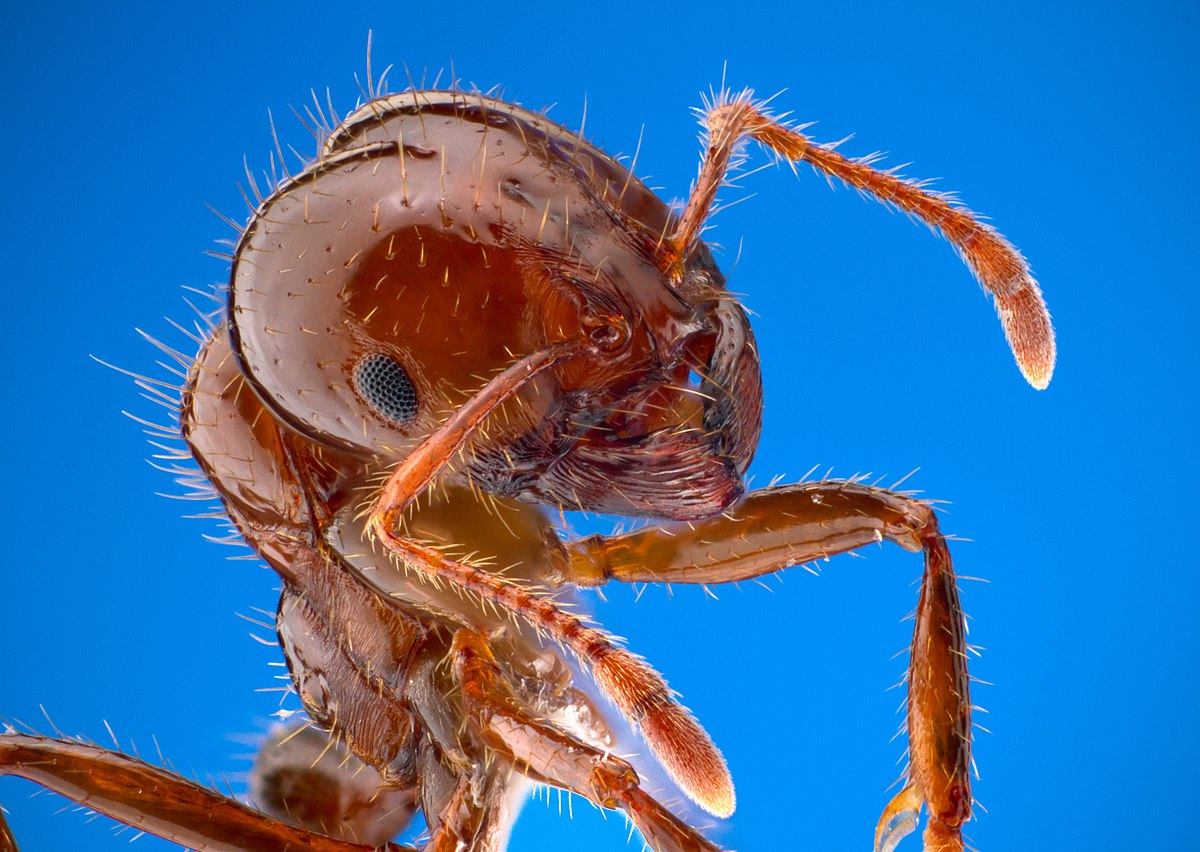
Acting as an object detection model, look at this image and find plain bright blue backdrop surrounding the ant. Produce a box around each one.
[0,2,1200,852]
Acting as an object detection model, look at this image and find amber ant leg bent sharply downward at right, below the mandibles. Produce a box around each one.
[562,482,971,852]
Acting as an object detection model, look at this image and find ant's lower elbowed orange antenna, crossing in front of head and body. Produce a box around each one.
[367,341,734,816]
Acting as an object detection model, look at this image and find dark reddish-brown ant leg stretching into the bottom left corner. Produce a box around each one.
[0,733,415,852]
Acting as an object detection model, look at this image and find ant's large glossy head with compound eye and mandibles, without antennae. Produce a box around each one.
[229,92,761,518]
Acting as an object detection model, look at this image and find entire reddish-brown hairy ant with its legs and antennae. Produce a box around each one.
[0,81,1054,852]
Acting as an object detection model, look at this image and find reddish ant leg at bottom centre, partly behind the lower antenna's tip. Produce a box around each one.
[451,629,720,852]
